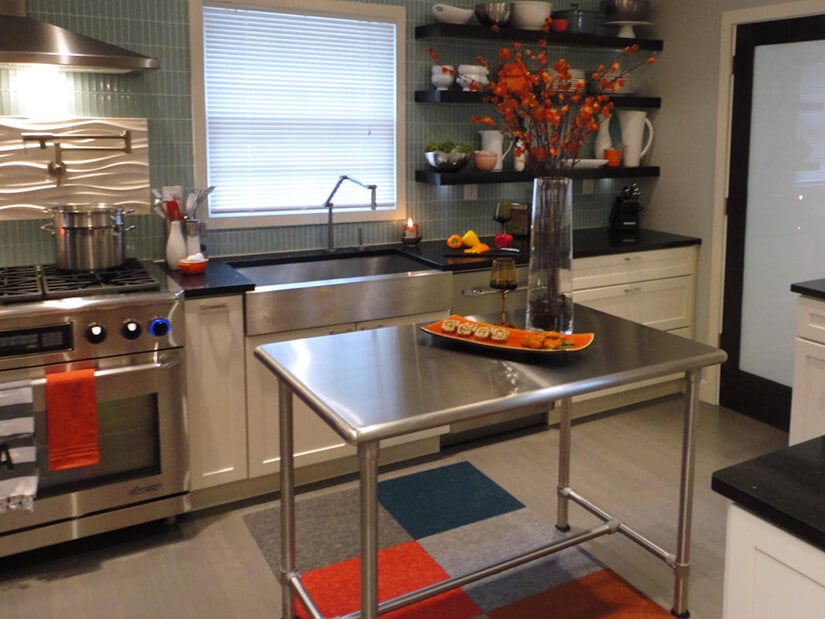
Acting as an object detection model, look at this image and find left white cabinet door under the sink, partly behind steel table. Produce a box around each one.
[246,324,355,477]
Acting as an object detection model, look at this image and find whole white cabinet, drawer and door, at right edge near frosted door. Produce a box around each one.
[788,296,825,445]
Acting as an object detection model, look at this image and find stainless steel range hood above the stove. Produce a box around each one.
[0,2,160,73]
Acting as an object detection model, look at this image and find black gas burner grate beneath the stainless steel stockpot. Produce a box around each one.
[42,258,160,299]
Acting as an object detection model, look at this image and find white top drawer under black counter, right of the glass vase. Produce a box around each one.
[573,247,696,290]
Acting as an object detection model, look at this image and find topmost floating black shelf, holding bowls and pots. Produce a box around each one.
[415,22,664,51]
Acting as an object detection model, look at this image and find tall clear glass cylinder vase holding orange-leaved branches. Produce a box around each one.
[526,177,573,333]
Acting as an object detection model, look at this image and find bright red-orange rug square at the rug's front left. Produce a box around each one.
[296,541,480,619]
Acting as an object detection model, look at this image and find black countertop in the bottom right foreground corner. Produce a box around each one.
[711,436,825,551]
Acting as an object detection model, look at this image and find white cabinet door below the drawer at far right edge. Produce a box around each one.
[788,338,825,445]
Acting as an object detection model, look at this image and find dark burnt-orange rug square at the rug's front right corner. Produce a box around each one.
[487,569,673,619]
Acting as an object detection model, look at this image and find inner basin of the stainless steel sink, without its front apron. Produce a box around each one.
[235,253,430,286]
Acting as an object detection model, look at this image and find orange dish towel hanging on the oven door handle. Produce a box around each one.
[46,369,100,471]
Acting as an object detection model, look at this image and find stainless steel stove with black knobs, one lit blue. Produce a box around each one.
[0,260,189,556]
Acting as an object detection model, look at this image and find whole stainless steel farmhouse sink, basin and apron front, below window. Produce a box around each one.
[233,252,452,336]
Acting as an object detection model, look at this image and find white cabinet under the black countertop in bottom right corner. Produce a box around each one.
[723,504,825,619]
